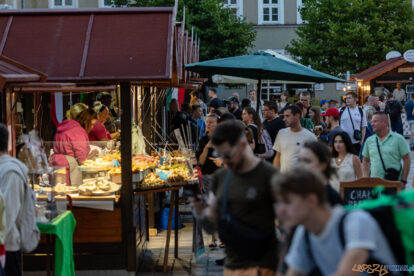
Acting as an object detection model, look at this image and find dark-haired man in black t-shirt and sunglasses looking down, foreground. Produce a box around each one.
[191,120,277,276]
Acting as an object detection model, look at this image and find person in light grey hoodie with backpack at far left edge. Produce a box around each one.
[0,124,40,275]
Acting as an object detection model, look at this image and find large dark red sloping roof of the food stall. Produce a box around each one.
[0,7,175,82]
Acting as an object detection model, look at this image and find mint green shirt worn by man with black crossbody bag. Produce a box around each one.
[362,131,410,178]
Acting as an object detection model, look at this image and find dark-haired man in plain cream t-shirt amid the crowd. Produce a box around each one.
[273,105,317,172]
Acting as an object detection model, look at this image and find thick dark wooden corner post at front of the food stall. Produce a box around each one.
[120,82,136,271]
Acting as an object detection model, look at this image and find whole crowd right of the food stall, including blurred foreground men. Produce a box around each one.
[191,87,414,276]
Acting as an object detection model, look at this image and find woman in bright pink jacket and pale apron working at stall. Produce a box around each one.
[51,108,97,186]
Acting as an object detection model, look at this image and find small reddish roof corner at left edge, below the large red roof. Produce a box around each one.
[0,56,47,89]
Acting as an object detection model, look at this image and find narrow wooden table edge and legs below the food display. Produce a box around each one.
[135,186,182,272]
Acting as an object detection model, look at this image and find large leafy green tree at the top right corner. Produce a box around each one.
[286,0,414,74]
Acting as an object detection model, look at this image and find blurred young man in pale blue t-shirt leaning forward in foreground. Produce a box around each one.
[272,168,400,276]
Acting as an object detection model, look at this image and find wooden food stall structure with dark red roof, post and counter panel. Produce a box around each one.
[0,4,202,271]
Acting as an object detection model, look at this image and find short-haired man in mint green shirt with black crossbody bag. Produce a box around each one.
[362,111,411,188]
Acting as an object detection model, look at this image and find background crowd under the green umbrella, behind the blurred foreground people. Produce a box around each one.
[182,88,414,190]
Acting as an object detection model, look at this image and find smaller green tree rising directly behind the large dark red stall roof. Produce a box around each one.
[131,0,256,60]
